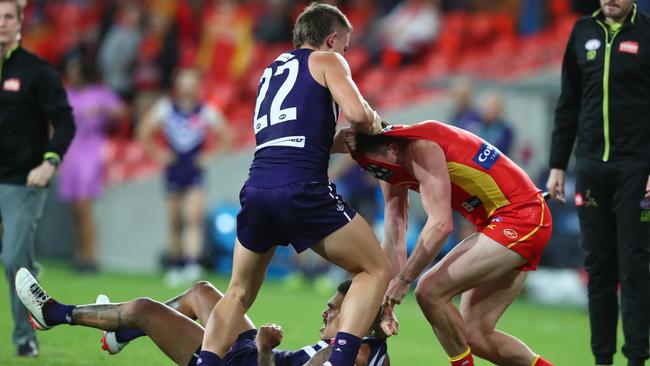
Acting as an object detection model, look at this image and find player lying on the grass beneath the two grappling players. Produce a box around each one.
[16,268,390,366]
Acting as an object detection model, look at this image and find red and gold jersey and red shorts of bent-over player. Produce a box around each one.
[353,121,552,269]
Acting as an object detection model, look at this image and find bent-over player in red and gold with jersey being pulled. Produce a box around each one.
[349,121,552,366]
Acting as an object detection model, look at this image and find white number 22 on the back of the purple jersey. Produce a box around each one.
[254,58,299,134]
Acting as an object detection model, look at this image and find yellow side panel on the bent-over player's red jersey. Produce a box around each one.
[447,162,510,217]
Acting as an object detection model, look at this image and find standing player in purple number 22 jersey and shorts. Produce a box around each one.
[201,3,390,366]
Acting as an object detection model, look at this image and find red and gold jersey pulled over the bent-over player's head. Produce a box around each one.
[354,121,540,225]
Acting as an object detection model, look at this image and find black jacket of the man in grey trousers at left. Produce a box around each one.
[0,47,75,184]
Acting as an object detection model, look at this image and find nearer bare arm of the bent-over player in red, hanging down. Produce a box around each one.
[386,140,453,304]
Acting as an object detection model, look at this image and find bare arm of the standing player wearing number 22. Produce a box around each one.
[309,51,381,135]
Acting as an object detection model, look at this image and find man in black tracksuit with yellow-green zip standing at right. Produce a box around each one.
[547,0,650,366]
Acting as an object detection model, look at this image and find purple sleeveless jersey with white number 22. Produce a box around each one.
[247,49,339,188]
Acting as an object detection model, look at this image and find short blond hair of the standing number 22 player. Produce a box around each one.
[293,2,352,48]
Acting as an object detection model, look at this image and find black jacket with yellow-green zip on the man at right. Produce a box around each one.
[550,5,650,169]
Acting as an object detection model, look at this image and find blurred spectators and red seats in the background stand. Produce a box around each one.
[23,0,597,151]
